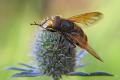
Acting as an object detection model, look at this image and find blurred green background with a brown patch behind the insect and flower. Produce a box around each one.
[0,0,120,80]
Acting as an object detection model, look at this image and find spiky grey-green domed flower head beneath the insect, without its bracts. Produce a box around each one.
[33,29,75,80]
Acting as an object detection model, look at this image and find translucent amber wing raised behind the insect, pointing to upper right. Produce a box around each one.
[68,12,103,26]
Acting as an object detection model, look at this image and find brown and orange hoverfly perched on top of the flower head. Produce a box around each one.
[32,12,102,61]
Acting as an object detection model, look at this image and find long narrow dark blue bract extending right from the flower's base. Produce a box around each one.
[68,72,113,76]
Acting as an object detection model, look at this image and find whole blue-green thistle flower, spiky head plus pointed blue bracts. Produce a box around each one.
[6,28,112,80]
